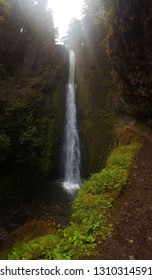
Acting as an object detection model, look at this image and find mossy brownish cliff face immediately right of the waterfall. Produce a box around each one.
[76,30,114,178]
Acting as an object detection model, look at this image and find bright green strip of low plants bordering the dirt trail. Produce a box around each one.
[8,138,141,260]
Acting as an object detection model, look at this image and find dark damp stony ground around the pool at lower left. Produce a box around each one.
[0,182,74,254]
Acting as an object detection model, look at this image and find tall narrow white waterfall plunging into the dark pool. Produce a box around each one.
[63,51,80,192]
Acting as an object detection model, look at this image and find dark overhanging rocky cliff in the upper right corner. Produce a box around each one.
[109,0,152,120]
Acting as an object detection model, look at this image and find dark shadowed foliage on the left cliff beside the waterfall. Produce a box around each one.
[0,81,57,180]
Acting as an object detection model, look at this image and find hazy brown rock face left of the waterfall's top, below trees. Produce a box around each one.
[0,30,57,76]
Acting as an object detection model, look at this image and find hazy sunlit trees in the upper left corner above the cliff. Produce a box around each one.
[0,0,55,73]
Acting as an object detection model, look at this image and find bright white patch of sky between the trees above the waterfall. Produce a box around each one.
[48,0,83,38]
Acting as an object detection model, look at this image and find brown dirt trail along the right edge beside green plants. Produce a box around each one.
[95,130,152,260]
